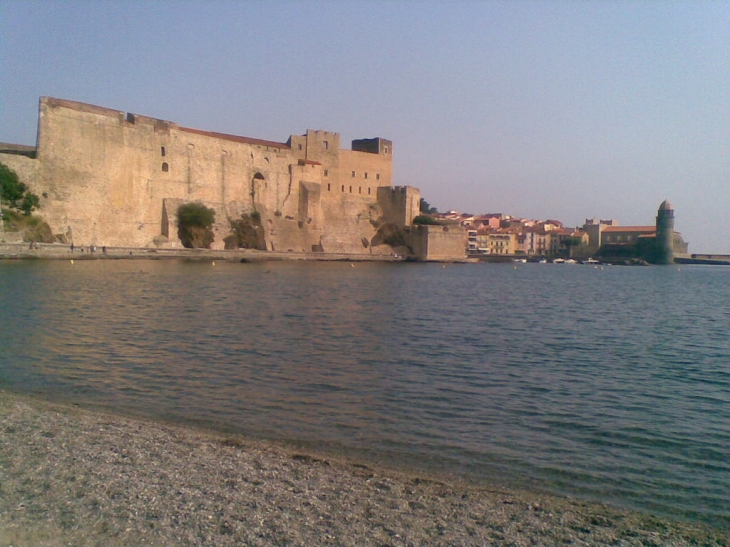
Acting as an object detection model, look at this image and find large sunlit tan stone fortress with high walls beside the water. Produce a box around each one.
[0,97,465,259]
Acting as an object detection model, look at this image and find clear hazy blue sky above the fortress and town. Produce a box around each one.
[0,0,730,254]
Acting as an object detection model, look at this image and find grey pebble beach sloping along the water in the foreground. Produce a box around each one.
[0,391,730,546]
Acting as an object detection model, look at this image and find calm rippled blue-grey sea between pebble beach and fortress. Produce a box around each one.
[0,260,730,526]
